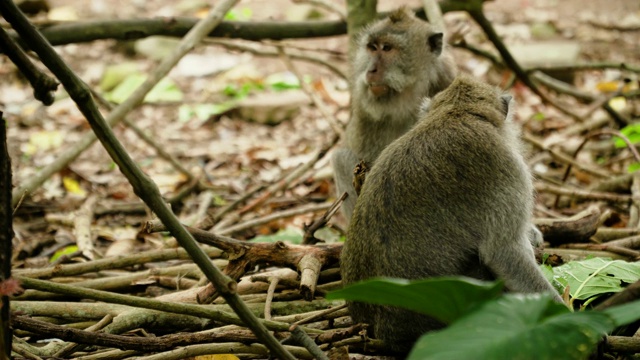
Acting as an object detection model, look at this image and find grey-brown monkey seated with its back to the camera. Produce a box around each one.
[341,76,562,352]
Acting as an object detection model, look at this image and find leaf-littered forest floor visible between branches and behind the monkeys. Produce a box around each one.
[0,0,640,359]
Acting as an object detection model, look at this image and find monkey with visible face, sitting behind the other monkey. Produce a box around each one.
[332,8,456,221]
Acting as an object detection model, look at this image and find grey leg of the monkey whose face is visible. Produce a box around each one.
[331,148,360,225]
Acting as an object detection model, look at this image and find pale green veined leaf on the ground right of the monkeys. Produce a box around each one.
[554,258,640,300]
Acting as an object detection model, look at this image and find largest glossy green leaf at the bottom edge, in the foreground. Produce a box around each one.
[408,294,614,360]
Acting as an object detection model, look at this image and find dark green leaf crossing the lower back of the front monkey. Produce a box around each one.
[327,277,503,323]
